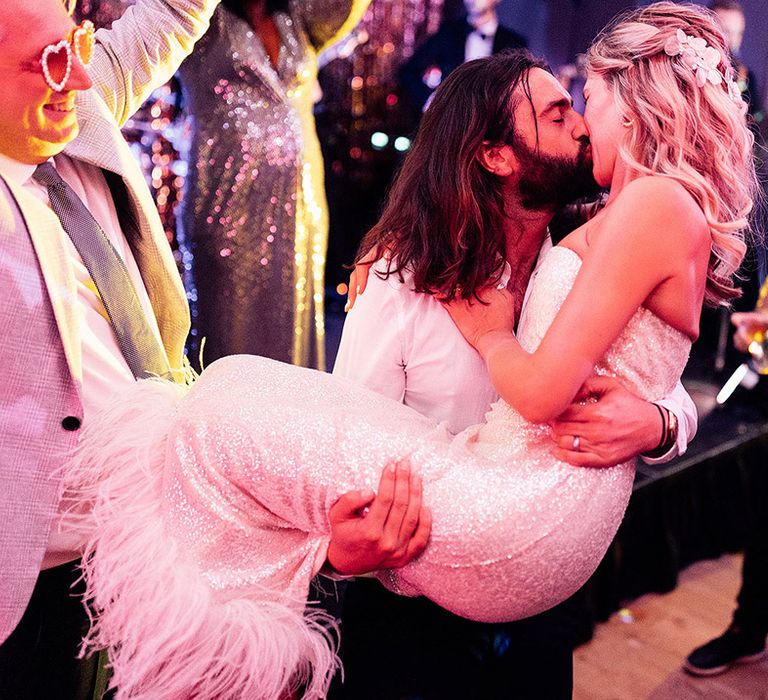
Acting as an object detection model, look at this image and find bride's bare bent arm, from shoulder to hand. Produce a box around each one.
[449,177,709,422]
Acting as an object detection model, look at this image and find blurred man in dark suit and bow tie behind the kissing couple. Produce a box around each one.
[400,0,528,113]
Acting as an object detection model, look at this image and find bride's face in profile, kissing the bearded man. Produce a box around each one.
[584,73,627,187]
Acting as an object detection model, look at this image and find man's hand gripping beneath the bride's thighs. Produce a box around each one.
[328,462,432,576]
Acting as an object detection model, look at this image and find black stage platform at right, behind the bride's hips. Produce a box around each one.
[582,364,768,641]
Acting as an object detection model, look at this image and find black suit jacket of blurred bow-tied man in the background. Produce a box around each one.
[400,19,528,113]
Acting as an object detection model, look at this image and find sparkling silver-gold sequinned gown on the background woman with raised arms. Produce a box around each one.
[179,0,370,369]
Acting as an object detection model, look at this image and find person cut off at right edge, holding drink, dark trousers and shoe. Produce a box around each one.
[684,288,768,676]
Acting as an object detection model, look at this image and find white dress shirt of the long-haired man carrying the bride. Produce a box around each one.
[333,238,697,463]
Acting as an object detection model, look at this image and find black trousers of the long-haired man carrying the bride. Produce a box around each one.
[329,580,584,700]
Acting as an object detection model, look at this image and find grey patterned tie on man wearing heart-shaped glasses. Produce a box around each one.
[33,162,171,379]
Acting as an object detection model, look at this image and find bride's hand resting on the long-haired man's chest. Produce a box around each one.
[443,287,515,352]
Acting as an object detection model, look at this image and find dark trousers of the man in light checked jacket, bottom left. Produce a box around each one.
[0,562,97,700]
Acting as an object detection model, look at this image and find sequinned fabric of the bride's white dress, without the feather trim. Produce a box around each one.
[162,248,690,621]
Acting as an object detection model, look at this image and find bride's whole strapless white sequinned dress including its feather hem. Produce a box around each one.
[64,247,690,700]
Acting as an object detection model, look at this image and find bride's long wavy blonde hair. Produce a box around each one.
[587,2,759,306]
